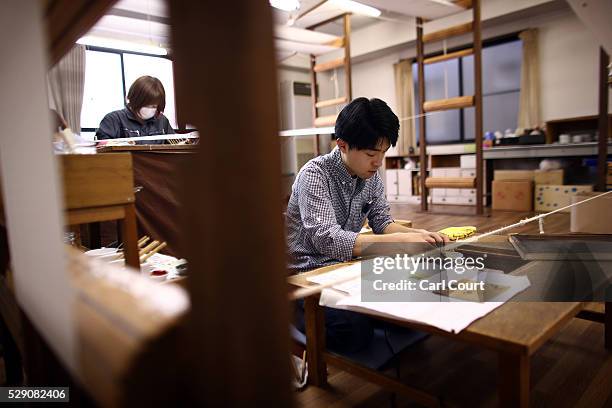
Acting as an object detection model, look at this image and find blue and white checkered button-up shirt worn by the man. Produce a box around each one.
[286,147,393,273]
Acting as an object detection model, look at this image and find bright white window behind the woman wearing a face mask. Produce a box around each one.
[81,47,177,138]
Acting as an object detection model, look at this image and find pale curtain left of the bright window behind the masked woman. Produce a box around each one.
[47,45,85,133]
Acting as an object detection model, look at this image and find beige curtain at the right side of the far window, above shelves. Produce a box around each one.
[518,28,541,128]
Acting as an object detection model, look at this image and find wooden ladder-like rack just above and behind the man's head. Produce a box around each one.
[308,13,352,155]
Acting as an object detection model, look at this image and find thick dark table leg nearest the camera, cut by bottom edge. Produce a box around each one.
[498,352,529,407]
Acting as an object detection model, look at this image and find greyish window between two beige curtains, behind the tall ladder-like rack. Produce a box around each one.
[412,39,522,144]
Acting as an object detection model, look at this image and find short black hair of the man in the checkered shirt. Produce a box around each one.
[335,97,399,150]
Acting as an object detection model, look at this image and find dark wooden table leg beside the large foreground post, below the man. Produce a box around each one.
[304,295,327,387]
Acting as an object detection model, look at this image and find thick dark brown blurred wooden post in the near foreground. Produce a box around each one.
[169,0,292,406]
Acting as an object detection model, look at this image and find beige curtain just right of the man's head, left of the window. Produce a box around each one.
[393,60,416,155]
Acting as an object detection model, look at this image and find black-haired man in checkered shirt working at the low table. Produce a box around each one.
[286,98,448,351]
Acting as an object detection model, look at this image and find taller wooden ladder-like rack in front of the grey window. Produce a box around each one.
[417,0,484,215]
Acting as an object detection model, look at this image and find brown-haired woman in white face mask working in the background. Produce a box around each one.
[96,75,174,144]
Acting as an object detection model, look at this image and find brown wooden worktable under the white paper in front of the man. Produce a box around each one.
[288,241,612,407]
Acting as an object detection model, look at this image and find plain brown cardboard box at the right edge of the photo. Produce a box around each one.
[570,193,612,234]
